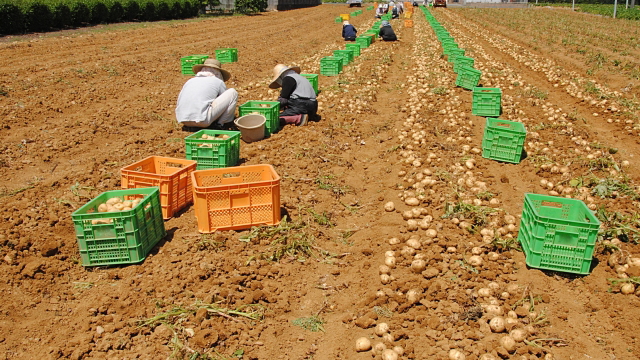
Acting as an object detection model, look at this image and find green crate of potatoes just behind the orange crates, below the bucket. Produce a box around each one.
[184,129,240,170]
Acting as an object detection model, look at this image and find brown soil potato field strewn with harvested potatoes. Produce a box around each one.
[0,4,640,360]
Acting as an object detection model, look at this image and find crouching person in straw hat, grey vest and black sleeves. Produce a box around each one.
[269,64,318,126]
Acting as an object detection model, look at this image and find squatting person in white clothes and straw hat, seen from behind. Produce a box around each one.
[176,59,238,129]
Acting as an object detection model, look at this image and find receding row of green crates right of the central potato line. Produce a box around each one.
[421,7,600,274]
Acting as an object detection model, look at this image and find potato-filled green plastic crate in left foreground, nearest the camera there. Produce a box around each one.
[71,187,166,266]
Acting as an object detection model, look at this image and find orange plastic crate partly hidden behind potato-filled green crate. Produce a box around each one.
[120,156,197,220]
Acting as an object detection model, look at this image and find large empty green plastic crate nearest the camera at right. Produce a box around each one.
[518,194,600,274]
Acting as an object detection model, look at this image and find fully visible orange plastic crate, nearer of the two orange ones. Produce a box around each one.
[191,165,280,233]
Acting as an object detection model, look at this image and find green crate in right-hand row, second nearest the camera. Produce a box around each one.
[482,118,527,164]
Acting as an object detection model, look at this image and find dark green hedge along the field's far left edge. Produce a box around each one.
[0,0,267,35]
